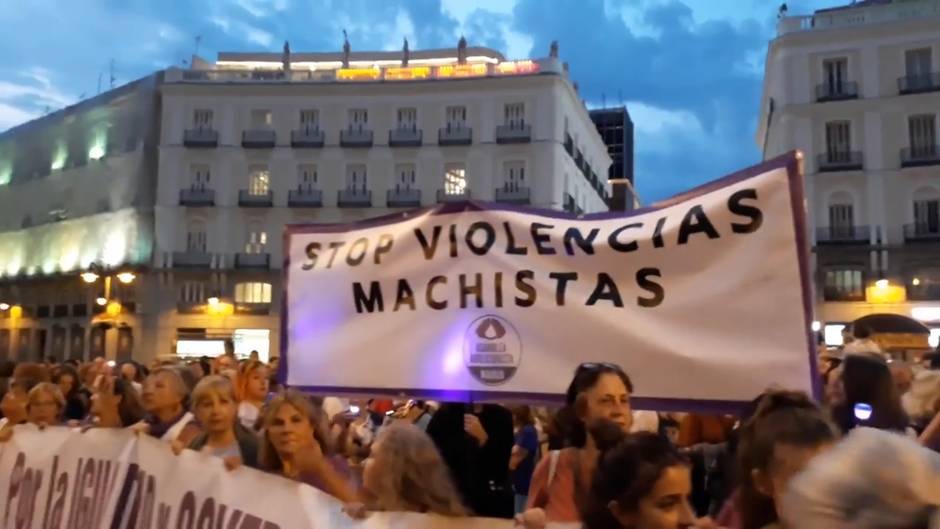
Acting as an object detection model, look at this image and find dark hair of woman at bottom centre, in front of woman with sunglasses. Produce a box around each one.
[579,425,689,529]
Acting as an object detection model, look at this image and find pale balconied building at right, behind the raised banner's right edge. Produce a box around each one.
[757,0,940,345]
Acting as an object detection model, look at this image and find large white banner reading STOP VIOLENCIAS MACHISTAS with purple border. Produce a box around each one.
[281,153,815,411]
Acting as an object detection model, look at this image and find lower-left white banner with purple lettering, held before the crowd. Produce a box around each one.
[0,426,564,529]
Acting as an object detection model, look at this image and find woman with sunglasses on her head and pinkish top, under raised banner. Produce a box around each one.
[517,363,633,527]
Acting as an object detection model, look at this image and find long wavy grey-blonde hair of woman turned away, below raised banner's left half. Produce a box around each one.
[362,423,469,516]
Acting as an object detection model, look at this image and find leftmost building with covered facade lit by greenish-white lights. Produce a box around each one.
[0,74,162,359]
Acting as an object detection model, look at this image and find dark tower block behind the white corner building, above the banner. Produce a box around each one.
[590,106,639,211]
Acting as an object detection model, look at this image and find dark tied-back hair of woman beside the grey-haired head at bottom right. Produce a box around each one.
[737,391,836,529]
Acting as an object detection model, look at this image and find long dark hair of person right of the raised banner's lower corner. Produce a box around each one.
[832,355,910,432]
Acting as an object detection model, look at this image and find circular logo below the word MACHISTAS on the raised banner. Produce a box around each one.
[463,315,522,386]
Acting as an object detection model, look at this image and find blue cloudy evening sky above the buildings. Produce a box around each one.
[0,0,836,203]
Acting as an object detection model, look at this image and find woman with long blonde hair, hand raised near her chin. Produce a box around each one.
[258,390,359,503]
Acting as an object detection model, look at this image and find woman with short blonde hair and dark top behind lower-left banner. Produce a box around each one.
[183,375,258,469]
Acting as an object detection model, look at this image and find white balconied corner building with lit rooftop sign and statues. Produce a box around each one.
[55,46,611,360]
